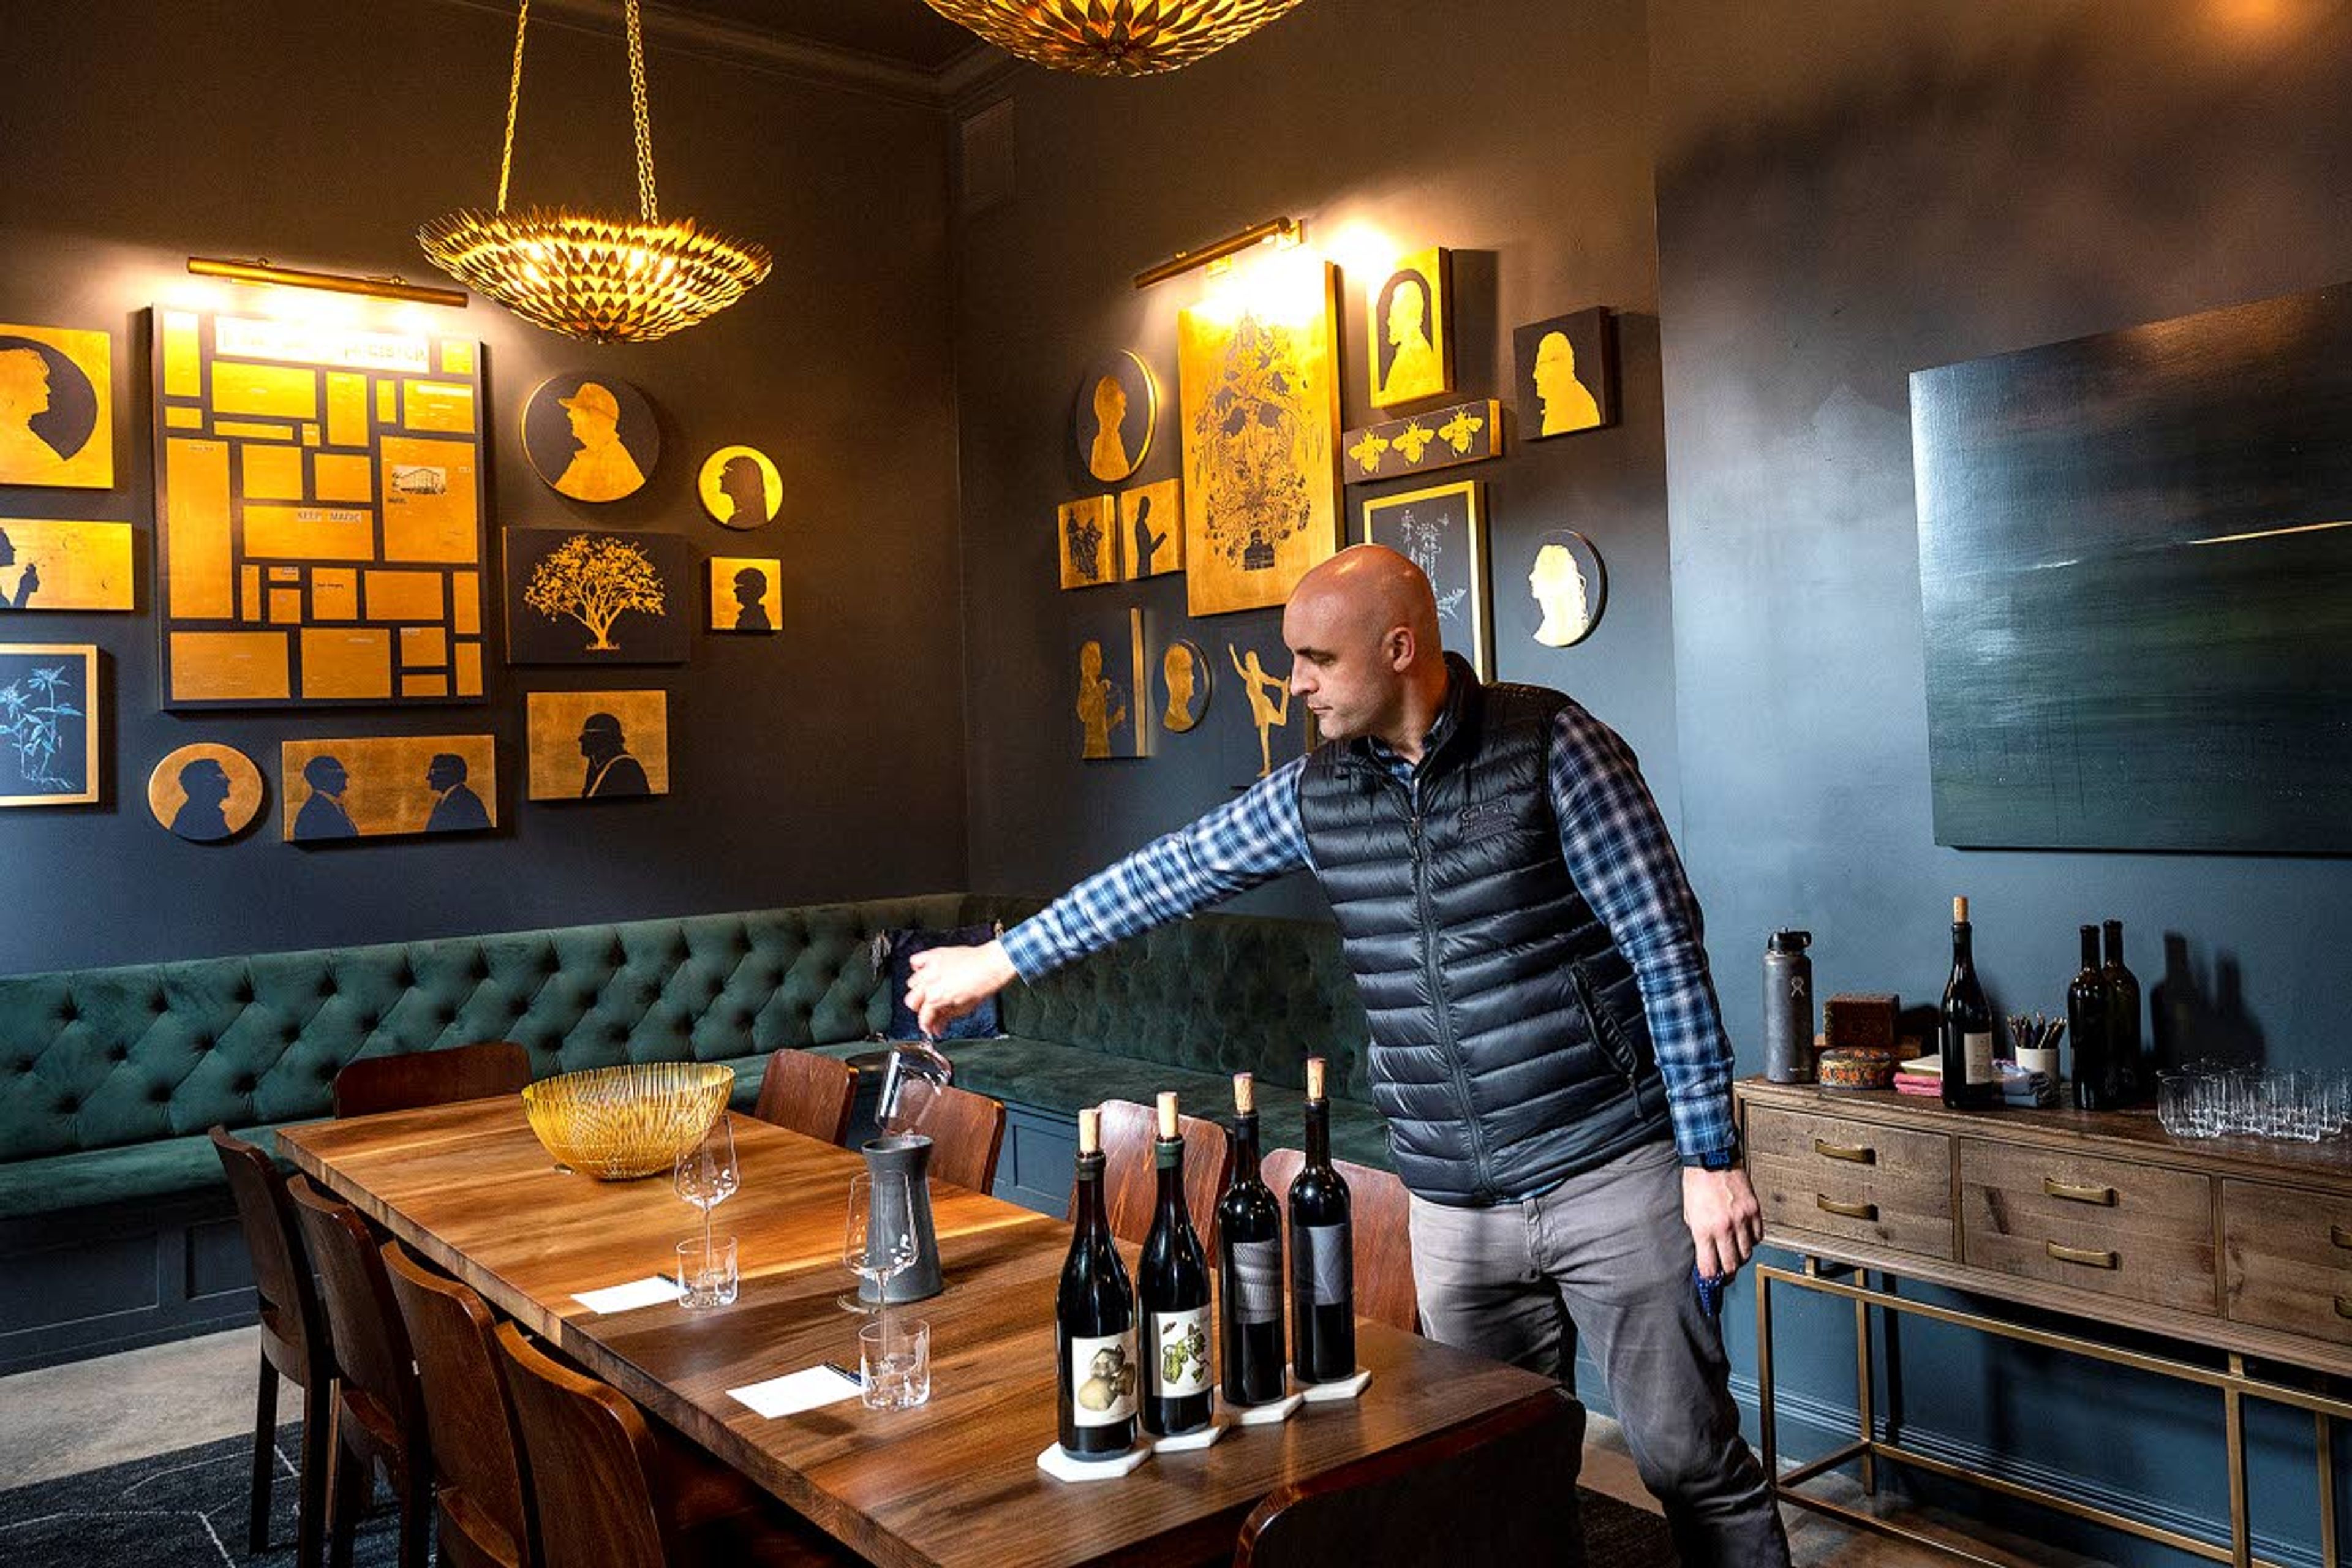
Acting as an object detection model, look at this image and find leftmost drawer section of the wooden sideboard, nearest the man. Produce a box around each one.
[1747,1105,1952,1257]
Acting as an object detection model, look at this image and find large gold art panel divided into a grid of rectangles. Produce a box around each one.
[155,306,484,707]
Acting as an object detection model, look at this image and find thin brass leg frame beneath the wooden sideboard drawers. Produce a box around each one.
[1755,1257,2352,1568]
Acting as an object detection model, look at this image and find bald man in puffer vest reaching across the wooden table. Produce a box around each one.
[908,545,1787,1568]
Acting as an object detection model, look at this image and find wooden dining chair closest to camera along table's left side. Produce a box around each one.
[499,1324,856,1568]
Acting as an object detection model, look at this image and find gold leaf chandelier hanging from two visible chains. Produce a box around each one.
[417,0,772,343]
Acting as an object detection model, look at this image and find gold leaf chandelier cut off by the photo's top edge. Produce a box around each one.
[927,0,1298,75]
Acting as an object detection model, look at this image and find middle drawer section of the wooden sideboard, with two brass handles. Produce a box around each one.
[1959,1138,2215,1314]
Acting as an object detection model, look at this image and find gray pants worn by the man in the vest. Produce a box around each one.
[1411,1142,1787,1568]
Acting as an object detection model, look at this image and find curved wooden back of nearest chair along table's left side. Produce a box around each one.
[499,1324,670,1568]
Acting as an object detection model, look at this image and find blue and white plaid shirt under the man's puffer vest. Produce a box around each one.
[1005,703,1738,1164]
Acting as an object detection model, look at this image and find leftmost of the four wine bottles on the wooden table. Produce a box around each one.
[1054,1110,1136,1460]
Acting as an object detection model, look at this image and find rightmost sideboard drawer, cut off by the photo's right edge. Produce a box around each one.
[2220,1180,2352,1344]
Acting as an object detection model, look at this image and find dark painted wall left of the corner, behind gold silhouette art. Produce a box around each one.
[0,0,964,971]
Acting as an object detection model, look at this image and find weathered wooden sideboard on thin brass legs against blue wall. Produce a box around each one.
[1736,1079,2352,1563]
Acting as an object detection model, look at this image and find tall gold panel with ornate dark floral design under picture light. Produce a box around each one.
[1176,252,1338,616]
